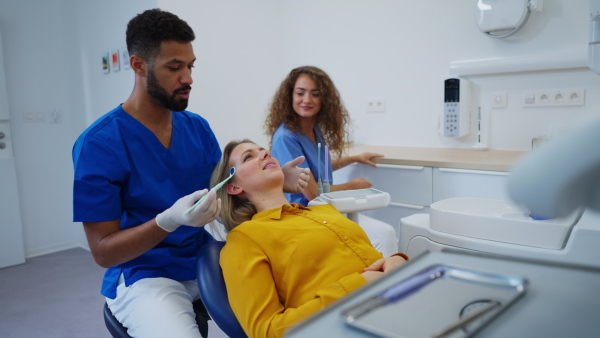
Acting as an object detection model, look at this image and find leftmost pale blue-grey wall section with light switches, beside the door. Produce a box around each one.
[0,0,83,257]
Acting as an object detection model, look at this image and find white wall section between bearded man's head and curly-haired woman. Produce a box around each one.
[158,0,285,147]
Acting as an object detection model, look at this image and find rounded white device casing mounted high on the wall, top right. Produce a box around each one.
[475,0,529,33]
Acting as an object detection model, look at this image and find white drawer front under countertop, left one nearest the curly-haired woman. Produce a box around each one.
[364,164,432,206]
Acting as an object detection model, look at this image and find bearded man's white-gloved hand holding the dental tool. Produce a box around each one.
[156,189,221,232]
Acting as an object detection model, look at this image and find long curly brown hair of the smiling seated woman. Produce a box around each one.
[265,66,352,158]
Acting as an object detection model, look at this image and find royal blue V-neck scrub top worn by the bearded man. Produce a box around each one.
[73,106,221,298]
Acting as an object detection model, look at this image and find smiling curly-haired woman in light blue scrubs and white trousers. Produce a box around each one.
[265,66,398,256]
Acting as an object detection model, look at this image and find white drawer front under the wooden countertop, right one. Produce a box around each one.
[433,168,510,202]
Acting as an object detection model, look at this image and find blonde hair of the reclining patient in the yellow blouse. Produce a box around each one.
[210,139,256,232]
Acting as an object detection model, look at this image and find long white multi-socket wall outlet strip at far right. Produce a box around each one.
[521,88,585,107]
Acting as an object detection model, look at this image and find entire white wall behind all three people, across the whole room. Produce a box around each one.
[0,0,600,257]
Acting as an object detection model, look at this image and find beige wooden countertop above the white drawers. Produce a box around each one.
[348,145,527,171]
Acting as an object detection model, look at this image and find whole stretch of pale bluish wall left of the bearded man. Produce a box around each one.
[0,0,156,257]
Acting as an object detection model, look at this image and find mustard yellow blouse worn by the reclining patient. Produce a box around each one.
[220,204,383,337]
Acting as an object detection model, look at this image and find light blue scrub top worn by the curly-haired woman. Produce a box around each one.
[271,124,333,206]
